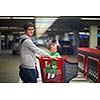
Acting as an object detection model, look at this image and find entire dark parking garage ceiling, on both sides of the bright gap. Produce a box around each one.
[0,16,100,34]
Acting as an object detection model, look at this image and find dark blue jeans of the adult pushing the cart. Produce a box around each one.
[19,65,38,83]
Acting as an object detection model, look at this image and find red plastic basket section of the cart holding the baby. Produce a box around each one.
[37,56,64,83]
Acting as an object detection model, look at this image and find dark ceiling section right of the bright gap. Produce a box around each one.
[45,16,100,34]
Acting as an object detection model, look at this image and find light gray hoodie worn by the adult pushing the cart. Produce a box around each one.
[20,35,50,69]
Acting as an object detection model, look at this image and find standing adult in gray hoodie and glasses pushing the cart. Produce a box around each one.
[19,22,50,83]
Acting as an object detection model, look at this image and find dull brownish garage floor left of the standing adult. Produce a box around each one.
[0,50,19,83]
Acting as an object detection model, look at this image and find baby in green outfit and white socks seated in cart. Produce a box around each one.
[46,43,61,79]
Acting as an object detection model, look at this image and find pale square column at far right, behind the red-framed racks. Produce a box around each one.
[89,26,98,48]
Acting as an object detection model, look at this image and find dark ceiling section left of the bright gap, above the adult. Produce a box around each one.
[0,17,35,34]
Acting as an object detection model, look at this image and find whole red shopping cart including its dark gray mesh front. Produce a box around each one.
[37,56,78,83]
